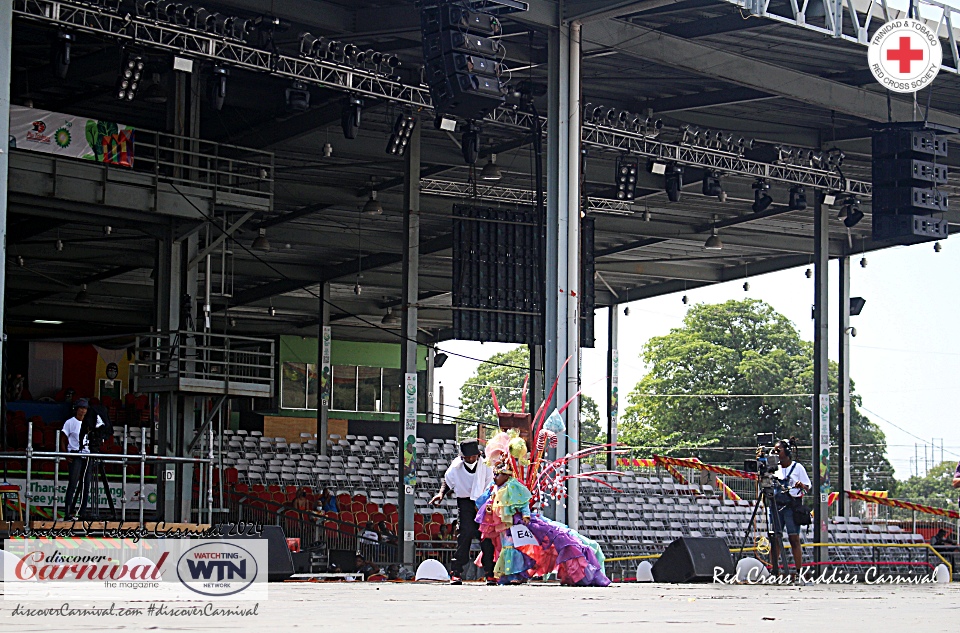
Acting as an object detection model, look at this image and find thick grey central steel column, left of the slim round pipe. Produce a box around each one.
[544,25,570,523]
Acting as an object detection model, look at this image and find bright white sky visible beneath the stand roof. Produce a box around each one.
[434,238,960,479]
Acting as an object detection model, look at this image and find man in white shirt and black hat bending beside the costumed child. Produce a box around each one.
[430,440,496,585]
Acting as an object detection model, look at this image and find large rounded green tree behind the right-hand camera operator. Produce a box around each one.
[618,299,893,490]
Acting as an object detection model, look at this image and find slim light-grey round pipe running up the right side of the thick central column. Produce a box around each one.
[565,20,583,530]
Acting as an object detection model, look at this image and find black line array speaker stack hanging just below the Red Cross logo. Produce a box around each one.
[871,121,957,244]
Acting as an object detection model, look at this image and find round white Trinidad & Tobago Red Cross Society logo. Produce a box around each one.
[867,19,943,92]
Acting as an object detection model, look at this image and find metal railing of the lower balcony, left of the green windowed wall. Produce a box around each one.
[131,330,275,397]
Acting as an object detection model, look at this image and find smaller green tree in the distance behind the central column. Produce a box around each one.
[460,345,601,442]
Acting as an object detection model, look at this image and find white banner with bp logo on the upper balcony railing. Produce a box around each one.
[8,105,134,167]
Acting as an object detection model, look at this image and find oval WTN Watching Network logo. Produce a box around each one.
[177,541,257,596]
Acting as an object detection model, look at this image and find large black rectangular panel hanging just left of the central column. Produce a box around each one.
[453,205,543,345]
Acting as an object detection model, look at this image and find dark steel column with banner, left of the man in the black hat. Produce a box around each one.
[397,117,420,567]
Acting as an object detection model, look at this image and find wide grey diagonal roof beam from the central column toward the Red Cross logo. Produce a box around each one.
[583,21,960,127]
